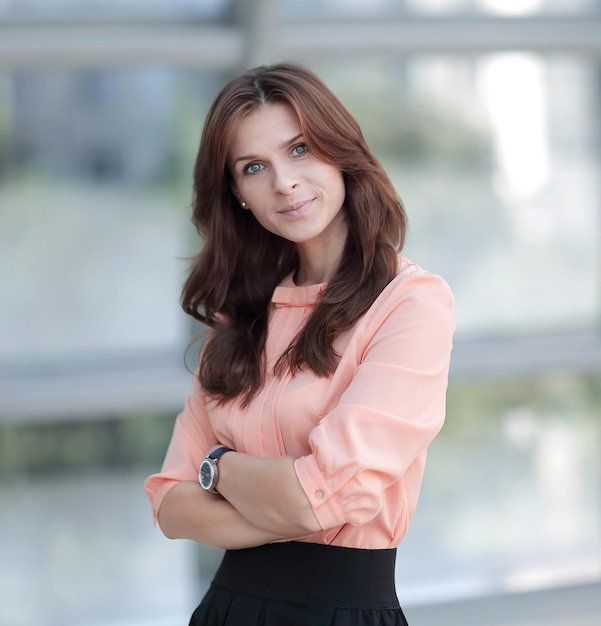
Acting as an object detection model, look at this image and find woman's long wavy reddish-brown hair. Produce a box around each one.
[181,63,407,406]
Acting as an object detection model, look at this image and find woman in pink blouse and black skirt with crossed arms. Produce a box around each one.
[145,59,454,626]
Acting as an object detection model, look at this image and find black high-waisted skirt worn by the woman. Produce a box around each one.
[190,542,407,626]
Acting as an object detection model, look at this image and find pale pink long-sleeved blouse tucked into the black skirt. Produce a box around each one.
[145,258,455,549]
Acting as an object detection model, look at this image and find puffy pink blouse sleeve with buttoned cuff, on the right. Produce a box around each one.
[295,270,455,530]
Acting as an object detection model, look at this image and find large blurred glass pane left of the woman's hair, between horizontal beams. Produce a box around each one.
[0,67,218,366]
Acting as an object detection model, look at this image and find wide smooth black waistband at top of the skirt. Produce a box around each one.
[214,542,399,608]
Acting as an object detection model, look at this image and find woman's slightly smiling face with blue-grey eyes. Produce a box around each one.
[228,103,347,260]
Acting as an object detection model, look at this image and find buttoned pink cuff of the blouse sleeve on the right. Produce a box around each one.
[294,454,346,530]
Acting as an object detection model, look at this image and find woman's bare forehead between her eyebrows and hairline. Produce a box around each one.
[229,102,302,159]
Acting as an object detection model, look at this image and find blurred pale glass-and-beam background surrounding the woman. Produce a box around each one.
[0,0,601,626]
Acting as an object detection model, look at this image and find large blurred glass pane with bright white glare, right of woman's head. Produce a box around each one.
[317,52,601,337]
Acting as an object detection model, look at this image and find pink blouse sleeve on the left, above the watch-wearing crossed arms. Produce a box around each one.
[144,376,217,521]
